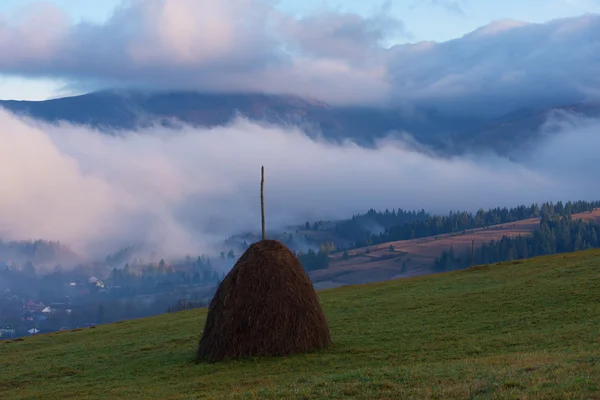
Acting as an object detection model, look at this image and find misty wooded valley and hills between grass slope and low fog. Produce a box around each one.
[0,201,600,339]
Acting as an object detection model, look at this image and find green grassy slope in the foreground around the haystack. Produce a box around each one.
[0,250,600,400]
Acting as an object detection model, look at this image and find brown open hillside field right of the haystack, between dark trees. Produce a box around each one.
[310,209,600,289]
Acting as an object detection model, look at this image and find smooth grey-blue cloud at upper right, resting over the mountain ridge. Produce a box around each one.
[388,14,600,116]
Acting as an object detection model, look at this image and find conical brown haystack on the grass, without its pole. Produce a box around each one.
[196,240,331,362]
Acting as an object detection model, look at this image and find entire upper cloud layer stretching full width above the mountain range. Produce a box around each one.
[0,0,600,116]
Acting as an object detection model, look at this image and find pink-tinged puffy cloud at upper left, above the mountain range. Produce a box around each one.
[0,0,404,103]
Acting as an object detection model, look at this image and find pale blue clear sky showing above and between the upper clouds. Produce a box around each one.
[0,0,600,100]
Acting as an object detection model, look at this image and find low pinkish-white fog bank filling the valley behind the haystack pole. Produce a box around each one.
[0,110,600,256]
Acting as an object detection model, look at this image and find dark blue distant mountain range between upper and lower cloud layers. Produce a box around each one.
[0,91,600,154]
